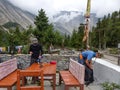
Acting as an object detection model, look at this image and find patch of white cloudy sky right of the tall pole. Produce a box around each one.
[91,0,120,16]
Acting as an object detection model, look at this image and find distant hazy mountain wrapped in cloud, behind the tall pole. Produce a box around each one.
[52,11,98,34]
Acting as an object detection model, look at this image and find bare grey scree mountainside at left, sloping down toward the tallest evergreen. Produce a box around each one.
[0,0,35,28]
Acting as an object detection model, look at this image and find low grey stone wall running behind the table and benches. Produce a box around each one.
[1,54,77,71]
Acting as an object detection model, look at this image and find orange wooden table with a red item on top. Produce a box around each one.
[26,63,56,90]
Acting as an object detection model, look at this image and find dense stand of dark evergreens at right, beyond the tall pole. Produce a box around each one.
[92,11,120,49]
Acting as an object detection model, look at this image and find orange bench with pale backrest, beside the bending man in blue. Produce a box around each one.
[59,59,85,90]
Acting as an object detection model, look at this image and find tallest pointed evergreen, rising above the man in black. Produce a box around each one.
[33,9,49,44]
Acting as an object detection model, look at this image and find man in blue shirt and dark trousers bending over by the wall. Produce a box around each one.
[78,50,99,85]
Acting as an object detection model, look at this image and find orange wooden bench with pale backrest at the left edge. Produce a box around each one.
[0,58,17,90]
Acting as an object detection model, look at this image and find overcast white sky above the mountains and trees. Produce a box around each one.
[9,0,120,16]
